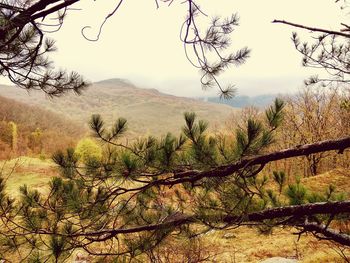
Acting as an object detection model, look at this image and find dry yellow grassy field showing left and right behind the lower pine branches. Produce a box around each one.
[0,157,350,263]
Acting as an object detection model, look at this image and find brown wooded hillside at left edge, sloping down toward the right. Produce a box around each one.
[0,96,84,158]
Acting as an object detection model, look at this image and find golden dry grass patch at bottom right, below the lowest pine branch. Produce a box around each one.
[204,227,350,263]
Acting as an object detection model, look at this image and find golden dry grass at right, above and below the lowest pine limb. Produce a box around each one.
[197,169,350,263]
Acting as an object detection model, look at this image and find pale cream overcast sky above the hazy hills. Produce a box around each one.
[2,0,344,96]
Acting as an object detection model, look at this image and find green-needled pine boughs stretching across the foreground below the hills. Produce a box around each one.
[0,100,350,262]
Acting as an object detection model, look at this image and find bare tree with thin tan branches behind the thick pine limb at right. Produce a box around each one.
[280,87,349,175]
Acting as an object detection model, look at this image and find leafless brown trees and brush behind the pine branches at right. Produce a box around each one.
[225,87,350,177]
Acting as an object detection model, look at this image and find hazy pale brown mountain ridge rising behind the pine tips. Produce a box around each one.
[0,79,236,137]
